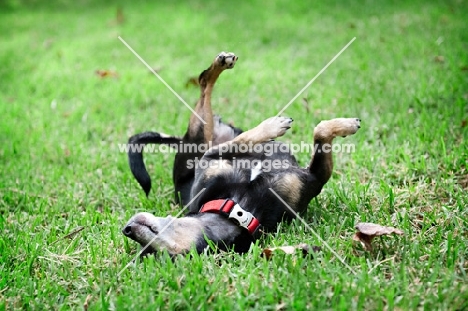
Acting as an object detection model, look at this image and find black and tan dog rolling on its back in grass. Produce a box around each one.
[122,52,360,255]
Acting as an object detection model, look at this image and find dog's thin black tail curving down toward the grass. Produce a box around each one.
[128,132,182,196]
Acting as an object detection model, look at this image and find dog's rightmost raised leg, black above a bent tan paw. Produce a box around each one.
[309,118,361,196]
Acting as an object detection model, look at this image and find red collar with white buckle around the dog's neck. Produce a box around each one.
[200,199,261,237]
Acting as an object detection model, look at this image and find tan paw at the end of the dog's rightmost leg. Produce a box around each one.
[315,118,361,138]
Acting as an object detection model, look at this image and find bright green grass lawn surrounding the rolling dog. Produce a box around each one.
[0,0,468,310]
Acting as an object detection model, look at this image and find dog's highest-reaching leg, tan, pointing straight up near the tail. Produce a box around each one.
[184,52,237,143]
